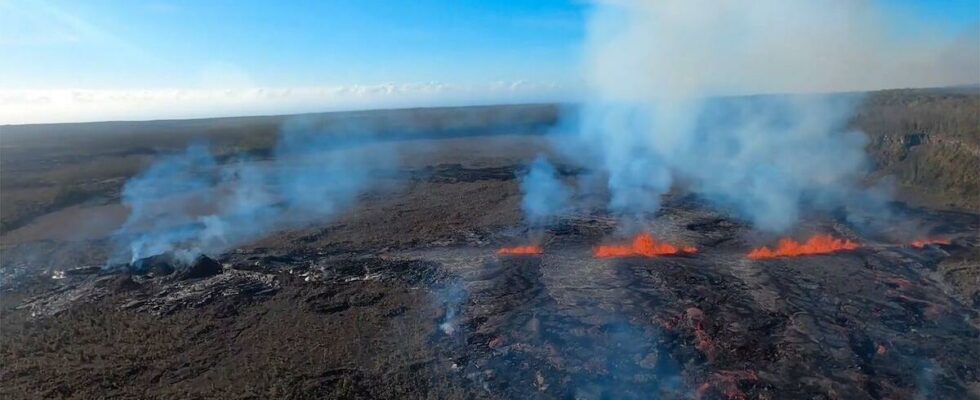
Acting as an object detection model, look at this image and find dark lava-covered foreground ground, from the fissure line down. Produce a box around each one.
[0,201,980,399]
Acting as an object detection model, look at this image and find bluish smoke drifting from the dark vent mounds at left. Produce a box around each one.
[109,118,395,264]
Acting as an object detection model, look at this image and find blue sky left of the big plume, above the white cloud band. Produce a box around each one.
[0,0,584,89]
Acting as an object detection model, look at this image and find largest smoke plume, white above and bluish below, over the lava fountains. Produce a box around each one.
[540,1,980,231]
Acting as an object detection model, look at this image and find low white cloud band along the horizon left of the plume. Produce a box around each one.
[0,81,574,124]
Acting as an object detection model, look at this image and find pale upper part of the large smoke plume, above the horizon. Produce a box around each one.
[586,0,980,99]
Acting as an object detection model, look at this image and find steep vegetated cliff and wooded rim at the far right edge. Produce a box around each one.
[854,89,980,211]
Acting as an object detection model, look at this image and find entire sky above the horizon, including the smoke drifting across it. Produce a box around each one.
[0,0,980,124]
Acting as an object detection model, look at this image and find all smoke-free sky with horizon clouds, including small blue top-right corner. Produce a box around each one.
[0,0,980,123]
